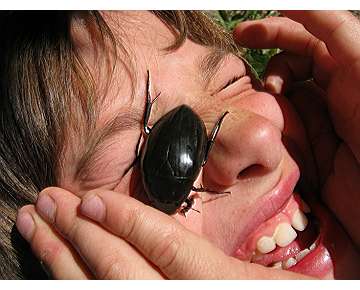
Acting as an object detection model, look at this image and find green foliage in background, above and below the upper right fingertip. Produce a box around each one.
[211,10,280,78]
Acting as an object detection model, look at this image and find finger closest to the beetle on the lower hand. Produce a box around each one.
[80,189,310,279]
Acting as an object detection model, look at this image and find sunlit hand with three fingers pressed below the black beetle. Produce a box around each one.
[17,187,304,279]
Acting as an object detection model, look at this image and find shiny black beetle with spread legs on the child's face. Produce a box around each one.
[134,72,229,214]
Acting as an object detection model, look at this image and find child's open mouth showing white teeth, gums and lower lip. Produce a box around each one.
[235,181,333,278]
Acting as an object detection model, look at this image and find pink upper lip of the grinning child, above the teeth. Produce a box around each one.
[234,168,300,259]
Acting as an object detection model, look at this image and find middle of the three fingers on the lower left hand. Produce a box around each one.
[32,187,162,279]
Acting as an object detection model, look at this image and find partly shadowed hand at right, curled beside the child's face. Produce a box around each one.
[234,11,360,248]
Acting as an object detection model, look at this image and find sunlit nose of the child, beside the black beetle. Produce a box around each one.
[203,110,283,188]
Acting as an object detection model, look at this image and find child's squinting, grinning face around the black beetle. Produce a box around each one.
[59,12,358,278]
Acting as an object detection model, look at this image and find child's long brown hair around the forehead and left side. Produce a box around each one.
[0,11,236,279]
